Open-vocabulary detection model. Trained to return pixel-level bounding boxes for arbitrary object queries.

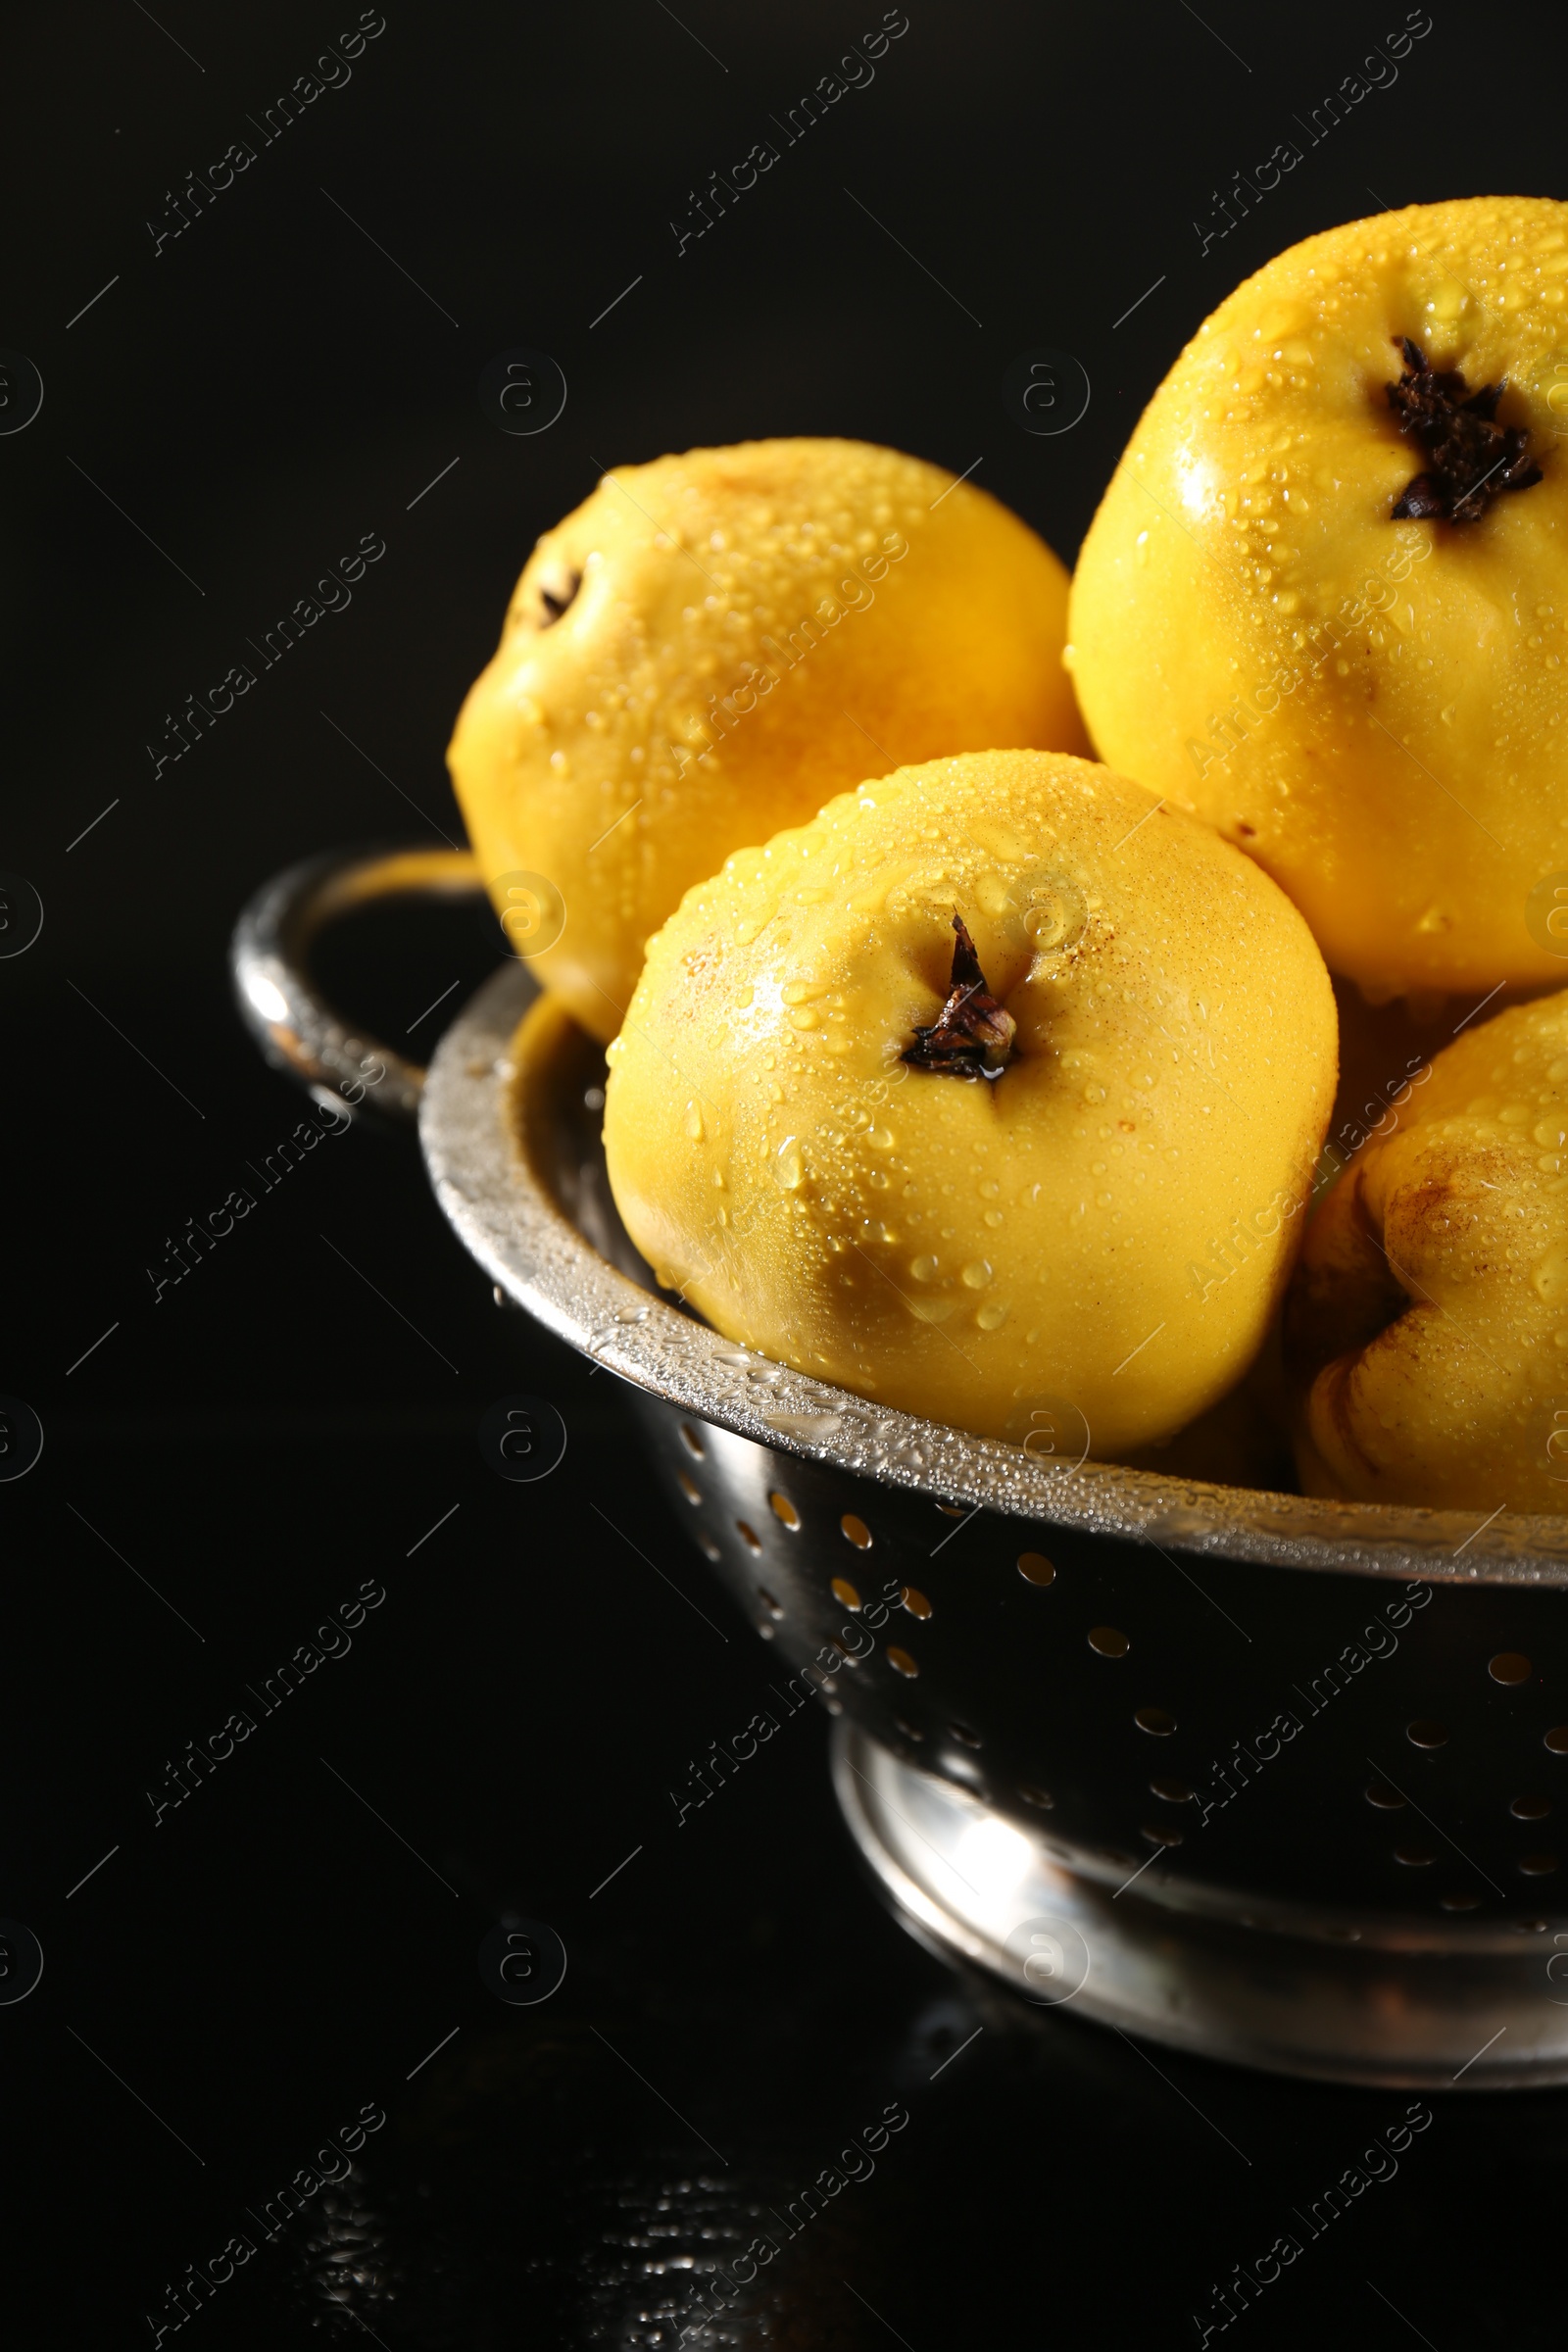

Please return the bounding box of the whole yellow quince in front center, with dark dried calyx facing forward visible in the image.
[604,751,1336,1458]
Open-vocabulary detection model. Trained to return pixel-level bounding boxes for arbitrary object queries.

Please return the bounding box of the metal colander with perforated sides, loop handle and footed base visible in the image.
[235,857,1568,2088]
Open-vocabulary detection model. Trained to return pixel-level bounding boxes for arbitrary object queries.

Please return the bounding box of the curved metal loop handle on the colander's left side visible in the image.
[228,847,484,1127]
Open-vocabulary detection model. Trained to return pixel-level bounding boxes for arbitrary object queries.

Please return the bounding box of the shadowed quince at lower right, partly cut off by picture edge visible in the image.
[1286,995,1568,1510]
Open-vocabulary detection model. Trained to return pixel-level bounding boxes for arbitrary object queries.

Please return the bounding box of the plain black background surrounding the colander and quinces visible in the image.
[0,0,1568,2352]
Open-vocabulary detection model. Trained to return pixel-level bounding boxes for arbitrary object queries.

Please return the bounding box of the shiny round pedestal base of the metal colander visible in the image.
[832,1719,1568,2091]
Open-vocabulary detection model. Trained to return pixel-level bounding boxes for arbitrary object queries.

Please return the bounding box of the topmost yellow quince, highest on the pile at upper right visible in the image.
[1067,198,1568,998]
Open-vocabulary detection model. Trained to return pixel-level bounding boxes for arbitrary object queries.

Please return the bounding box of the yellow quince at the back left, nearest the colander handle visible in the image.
[447,440,1086,1037]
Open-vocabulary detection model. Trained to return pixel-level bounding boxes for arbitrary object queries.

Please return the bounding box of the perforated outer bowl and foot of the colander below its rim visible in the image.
[632,1393,1568,2088]
